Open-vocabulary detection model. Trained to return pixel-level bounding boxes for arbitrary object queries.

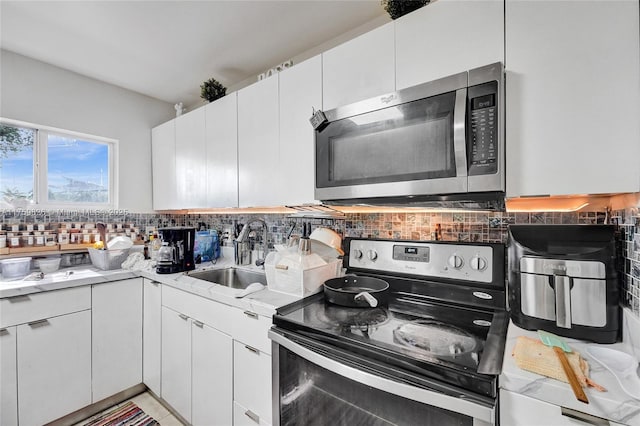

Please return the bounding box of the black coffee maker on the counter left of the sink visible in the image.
[156,226,196,274]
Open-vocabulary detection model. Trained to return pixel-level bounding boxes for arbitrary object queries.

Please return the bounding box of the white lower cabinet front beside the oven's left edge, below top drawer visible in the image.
[233,340,271,422]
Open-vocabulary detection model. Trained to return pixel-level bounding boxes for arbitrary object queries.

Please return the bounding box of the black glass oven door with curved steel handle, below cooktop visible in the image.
[269,327,495,426]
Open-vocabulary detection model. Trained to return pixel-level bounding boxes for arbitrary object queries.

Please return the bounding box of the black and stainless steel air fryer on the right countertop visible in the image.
[508,225,620,343]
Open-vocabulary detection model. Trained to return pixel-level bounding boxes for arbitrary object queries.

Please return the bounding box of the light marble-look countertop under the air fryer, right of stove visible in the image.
[499,313,640,426]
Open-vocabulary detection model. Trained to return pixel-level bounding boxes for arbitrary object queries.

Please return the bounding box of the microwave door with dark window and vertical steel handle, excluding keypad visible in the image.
[315,72,468,201]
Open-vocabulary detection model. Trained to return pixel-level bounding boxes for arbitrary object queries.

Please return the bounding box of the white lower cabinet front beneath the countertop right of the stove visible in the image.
[500,389,622,426]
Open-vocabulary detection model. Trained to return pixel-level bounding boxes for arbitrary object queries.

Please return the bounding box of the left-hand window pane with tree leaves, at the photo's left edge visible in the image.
[0,124,36,207]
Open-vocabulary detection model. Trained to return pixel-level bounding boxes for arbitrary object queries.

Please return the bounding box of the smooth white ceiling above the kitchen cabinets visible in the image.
[0,0,390,106]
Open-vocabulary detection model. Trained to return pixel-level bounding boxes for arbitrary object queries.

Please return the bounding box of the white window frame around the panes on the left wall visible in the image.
[0,118,120,210]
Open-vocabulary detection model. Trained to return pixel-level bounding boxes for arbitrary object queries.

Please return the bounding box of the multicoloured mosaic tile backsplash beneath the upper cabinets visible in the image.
[0,208,640,317]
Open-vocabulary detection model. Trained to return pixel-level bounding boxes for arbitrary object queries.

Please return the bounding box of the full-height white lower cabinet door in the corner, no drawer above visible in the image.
[91,278,142,402]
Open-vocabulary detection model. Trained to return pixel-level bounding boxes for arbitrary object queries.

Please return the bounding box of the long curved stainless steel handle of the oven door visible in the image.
[269,330,495,425]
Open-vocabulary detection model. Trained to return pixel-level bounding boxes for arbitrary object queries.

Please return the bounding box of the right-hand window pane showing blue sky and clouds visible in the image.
[47,135,109,203]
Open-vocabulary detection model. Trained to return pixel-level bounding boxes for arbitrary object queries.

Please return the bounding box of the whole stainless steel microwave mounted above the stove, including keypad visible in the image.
[315,63,505,208]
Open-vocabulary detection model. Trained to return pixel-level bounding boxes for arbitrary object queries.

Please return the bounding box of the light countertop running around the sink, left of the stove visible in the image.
[0,251,299,316]
